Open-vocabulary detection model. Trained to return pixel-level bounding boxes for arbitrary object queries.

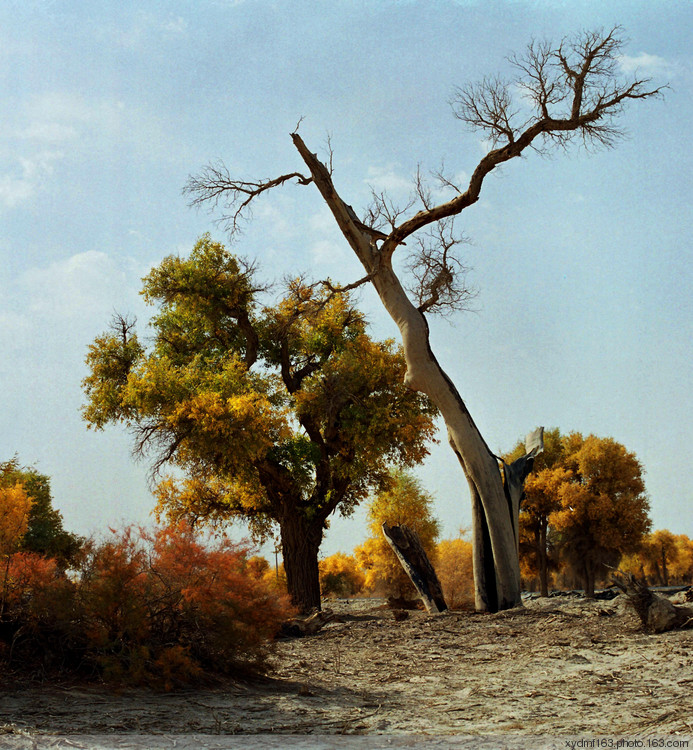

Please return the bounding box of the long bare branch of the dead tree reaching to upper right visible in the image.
[381,27,667,254]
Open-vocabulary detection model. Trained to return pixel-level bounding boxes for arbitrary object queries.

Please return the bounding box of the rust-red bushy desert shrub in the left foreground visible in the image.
[0,525,291,689]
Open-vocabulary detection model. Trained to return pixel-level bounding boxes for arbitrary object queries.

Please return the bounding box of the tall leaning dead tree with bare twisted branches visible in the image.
[186,28,664,611]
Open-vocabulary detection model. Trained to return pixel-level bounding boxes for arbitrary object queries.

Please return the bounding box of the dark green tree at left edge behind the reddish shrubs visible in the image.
[0,457,84,568]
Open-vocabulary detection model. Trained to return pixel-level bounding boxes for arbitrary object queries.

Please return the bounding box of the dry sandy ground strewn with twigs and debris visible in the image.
[0,597,693,747]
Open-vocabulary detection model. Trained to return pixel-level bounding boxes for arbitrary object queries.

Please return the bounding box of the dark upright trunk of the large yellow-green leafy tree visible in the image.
[279,511,322,614]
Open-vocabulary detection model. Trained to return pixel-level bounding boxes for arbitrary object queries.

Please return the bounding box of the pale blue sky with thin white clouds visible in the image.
[0,0,693,554]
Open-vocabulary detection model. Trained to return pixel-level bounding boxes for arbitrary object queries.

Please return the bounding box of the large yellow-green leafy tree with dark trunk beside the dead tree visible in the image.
[84,236,436,611]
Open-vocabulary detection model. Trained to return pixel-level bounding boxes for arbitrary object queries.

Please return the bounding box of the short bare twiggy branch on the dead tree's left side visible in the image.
[183,161,312,234]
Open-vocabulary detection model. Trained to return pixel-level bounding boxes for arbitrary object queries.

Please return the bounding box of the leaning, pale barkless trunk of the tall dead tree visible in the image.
[292,133,521,612]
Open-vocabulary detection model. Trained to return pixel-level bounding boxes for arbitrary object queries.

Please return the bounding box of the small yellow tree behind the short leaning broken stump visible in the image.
[354,471,440,599]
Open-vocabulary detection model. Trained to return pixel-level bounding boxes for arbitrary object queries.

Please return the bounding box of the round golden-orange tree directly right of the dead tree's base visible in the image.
[505,429,650,596]
